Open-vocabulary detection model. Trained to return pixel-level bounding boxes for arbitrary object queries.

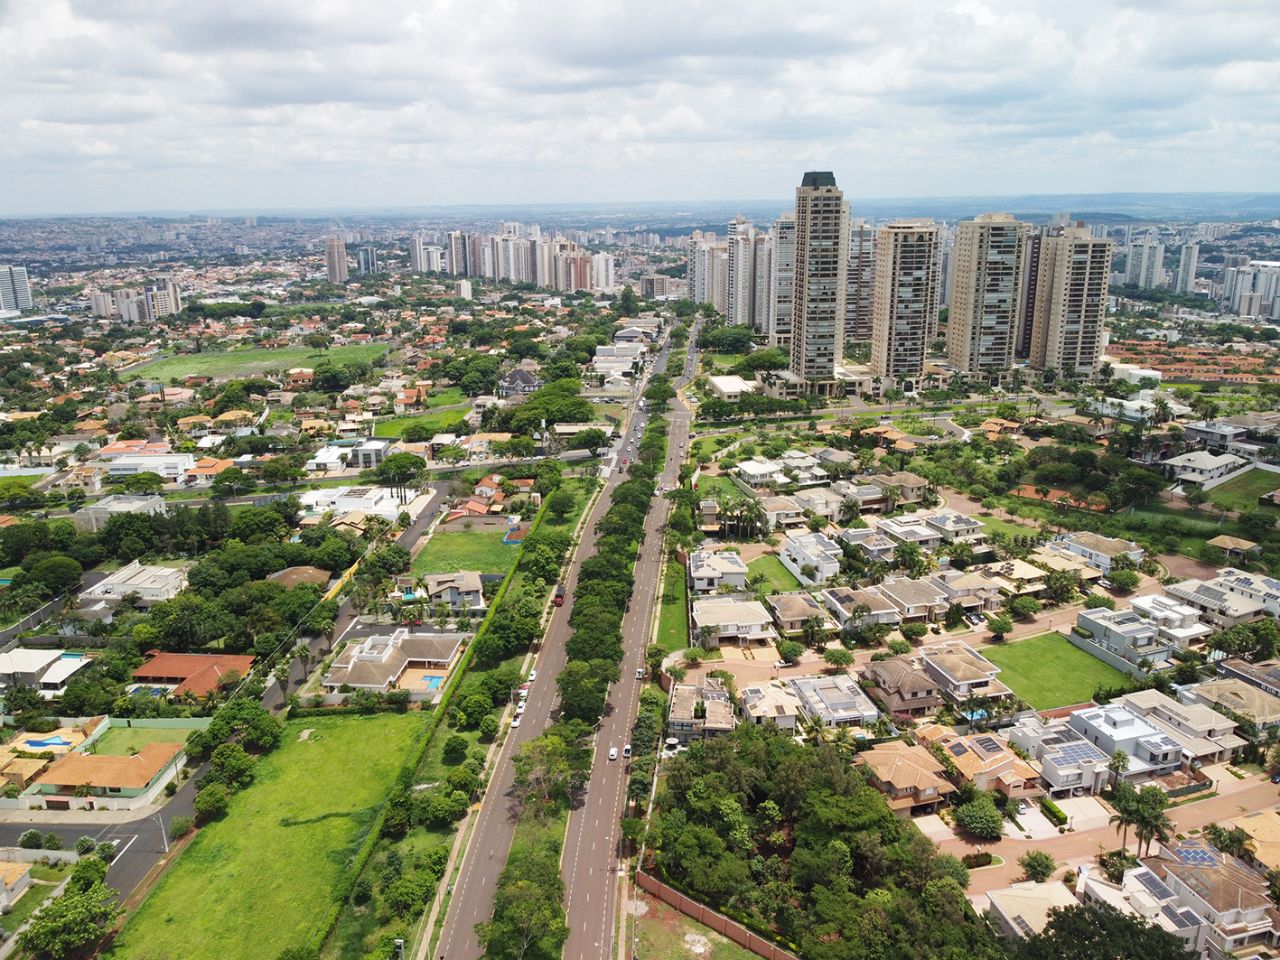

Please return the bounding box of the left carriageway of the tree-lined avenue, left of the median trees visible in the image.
[430,351,687,960]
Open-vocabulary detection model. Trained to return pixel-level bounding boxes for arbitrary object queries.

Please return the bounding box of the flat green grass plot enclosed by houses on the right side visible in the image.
[982,632,1124,710]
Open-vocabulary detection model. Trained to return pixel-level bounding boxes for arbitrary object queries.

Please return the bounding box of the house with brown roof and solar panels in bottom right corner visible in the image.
[1146,840,1280,960]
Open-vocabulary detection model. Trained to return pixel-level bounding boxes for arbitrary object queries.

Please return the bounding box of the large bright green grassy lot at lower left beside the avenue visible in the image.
[104,713,422,960]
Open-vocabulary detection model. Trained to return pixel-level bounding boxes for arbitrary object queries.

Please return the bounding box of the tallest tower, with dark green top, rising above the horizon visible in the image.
[791,170,849,393]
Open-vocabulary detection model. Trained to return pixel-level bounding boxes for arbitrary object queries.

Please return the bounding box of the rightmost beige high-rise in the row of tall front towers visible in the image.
[1030,224,1111,376]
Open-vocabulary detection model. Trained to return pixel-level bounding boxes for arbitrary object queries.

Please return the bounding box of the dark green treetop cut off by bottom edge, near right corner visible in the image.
[1015,904,1199,960]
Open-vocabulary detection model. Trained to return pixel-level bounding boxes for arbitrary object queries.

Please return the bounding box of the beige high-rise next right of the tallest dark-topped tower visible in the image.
[872,220,942,389]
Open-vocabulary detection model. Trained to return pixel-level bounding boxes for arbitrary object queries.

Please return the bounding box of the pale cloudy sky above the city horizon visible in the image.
[0,0,1280,215]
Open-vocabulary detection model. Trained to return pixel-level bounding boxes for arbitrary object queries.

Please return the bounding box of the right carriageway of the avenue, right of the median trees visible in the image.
[561,360,690,960]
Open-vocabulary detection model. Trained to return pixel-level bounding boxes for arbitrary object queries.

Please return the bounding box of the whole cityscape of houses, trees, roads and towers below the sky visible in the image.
[0,179,1280,960]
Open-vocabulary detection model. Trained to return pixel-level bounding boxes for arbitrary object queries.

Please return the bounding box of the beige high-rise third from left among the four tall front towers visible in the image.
[947,214,1025,375]
